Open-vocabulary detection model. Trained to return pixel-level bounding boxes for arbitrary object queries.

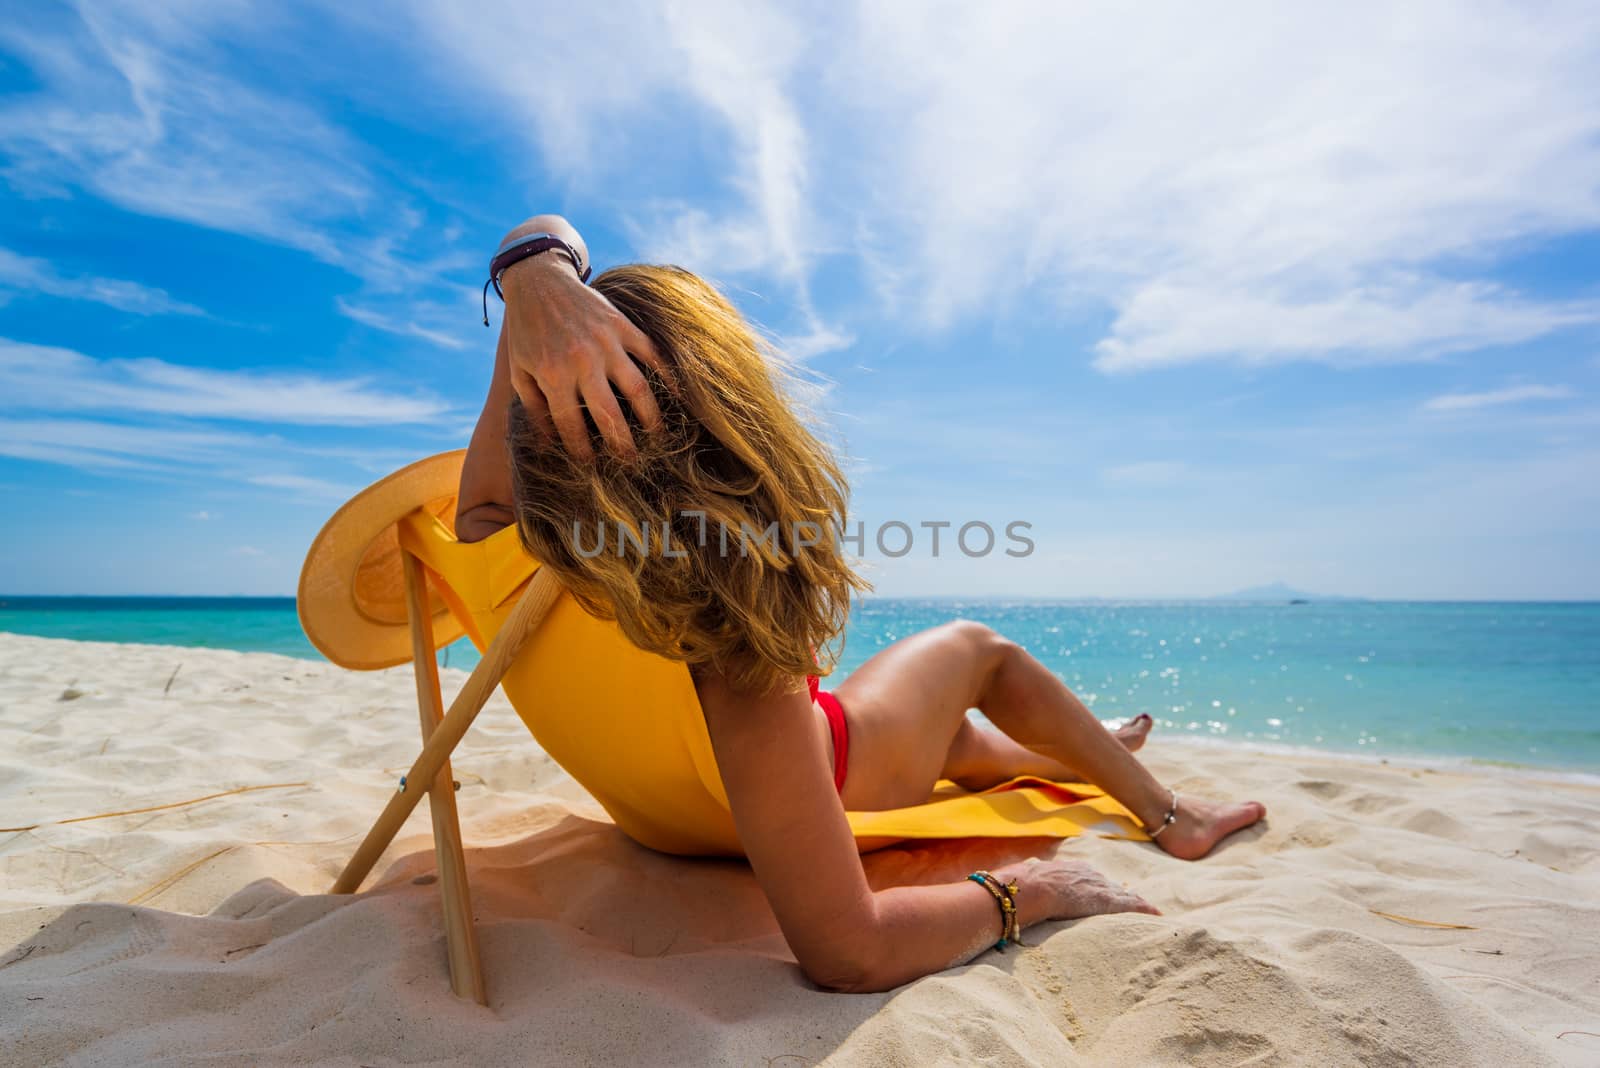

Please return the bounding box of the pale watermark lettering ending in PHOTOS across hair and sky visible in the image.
[573,512,1034,560]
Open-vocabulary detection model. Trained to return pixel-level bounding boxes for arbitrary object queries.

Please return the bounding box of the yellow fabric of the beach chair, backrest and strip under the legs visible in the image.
[400,502,1146,855]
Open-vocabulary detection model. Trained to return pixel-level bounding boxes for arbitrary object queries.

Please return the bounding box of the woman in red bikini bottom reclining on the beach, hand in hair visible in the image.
[456,216,1264,991]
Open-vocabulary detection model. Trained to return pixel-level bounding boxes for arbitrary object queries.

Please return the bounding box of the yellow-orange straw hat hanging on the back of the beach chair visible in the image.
[296,449,467,671]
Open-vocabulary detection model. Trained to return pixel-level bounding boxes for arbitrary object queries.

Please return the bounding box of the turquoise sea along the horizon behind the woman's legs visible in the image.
[0,598,1600,772]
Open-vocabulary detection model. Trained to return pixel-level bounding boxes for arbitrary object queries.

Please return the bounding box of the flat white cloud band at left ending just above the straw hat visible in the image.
[0,339,450,427]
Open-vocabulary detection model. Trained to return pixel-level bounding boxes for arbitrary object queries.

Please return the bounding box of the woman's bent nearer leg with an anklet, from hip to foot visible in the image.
[835,620,1266,859]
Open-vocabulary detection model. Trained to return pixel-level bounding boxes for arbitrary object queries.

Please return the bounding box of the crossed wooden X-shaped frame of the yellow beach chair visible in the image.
[331,550,562,1006]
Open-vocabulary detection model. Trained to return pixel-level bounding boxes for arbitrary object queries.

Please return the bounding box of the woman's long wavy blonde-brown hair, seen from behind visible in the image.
[510,264,869,692]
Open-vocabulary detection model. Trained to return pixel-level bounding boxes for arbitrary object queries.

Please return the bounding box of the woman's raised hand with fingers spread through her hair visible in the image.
[501,253,667,459]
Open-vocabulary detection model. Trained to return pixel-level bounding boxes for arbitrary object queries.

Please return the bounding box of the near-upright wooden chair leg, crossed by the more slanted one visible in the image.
[402,553,488,1006]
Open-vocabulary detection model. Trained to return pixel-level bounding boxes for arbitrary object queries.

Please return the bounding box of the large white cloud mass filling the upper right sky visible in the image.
[842,3,1600,369]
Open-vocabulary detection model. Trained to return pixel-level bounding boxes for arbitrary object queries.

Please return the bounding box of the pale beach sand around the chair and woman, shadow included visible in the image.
[0,635,1600,1068]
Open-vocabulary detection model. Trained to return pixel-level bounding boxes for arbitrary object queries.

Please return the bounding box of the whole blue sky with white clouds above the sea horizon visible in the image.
[0,0,1600,598]
